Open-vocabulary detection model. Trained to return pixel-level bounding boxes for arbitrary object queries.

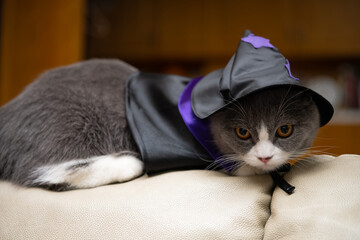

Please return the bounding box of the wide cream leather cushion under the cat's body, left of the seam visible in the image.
[0,171,272,239]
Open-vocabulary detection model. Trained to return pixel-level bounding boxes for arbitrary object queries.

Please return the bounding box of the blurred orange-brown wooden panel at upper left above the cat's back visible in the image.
[0,0,85,106]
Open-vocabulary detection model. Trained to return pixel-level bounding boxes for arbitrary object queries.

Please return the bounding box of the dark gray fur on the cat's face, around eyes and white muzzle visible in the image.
[210,86,320,172]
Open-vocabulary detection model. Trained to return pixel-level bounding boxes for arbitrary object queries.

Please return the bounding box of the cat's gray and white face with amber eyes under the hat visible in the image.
[210,87,320,172]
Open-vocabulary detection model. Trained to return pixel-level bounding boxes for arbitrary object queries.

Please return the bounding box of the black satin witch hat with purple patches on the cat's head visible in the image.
[191,30,334,126]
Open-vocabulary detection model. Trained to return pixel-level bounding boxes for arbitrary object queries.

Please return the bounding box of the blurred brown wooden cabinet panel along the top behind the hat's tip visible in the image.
[88,0,360,61]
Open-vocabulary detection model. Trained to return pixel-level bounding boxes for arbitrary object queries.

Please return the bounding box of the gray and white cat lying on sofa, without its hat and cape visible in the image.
[0,60,319,190]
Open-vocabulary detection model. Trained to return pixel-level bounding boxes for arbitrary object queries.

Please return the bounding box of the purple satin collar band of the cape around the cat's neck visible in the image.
[178,77,235,172]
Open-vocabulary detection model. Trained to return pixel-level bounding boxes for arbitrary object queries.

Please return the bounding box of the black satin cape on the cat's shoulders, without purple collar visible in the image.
[126,72,213,174]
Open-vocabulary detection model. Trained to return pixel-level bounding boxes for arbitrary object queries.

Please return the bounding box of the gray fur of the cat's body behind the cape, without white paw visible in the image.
[0,60,137,187]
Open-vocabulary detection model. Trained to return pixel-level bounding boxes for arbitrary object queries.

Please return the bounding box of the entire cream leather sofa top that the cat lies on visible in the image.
[0,155,360,240]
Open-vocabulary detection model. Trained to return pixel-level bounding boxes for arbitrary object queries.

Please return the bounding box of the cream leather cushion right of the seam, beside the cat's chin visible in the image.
[265,155,360,240]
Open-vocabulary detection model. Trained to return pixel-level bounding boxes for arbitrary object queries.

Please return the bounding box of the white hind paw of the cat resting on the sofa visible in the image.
[33,155,144,188]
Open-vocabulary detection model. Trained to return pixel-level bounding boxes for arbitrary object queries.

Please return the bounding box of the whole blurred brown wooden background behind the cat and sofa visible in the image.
[0,0,360,154]
